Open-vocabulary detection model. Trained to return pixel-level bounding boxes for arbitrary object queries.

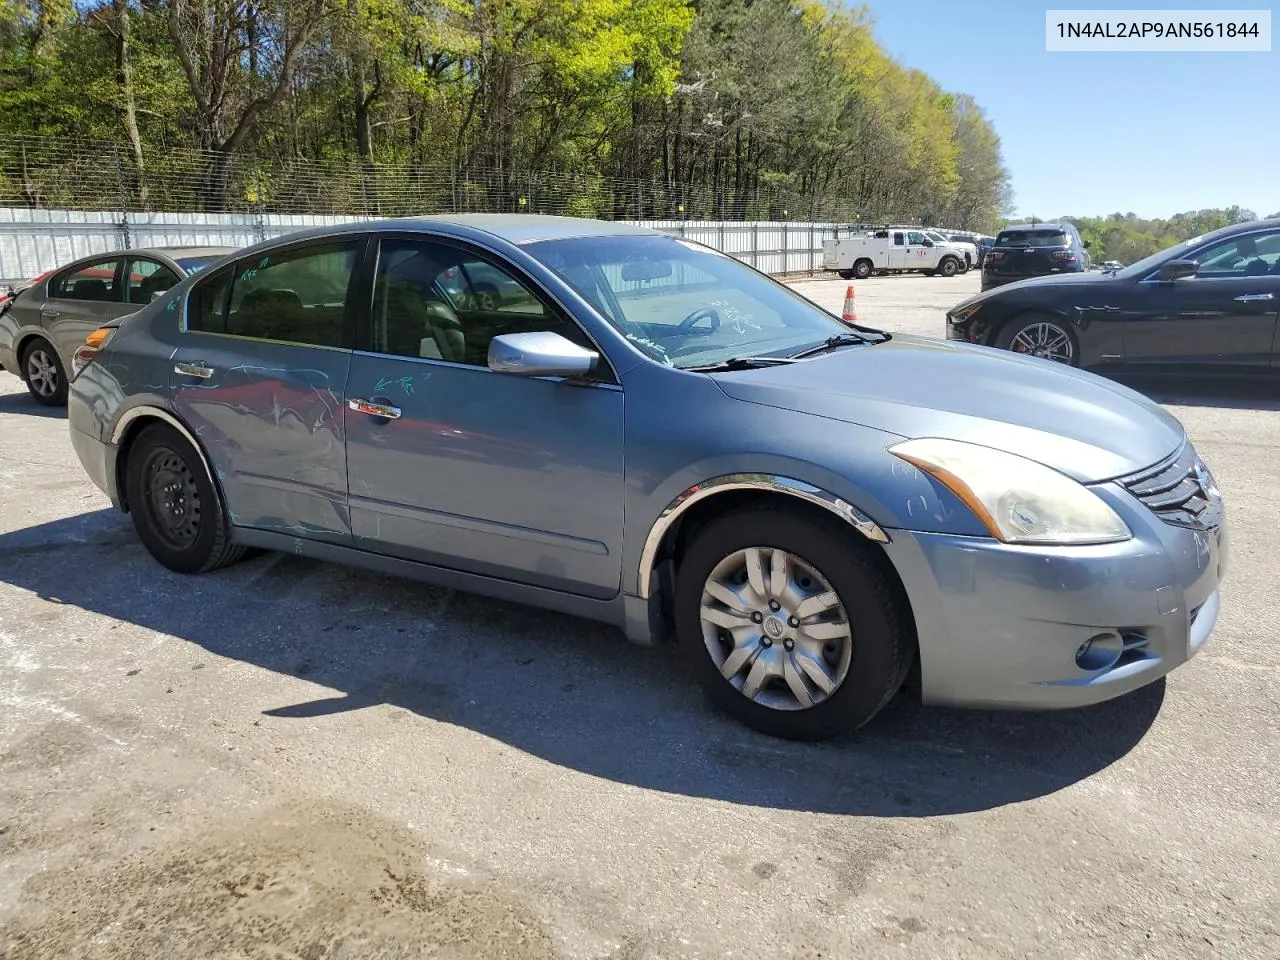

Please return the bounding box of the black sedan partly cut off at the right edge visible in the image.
[947,219,1280,374]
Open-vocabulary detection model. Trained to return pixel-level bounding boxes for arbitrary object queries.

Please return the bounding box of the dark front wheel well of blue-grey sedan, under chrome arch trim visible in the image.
[654,490,919,676]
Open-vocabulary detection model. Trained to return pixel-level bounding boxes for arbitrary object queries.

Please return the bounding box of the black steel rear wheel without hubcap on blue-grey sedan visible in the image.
[124,424,244,573]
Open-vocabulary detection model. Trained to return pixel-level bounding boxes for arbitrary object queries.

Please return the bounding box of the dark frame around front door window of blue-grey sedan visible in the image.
[355,230,622,389]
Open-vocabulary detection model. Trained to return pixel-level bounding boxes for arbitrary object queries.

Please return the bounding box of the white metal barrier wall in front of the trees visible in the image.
[0,207,840,283]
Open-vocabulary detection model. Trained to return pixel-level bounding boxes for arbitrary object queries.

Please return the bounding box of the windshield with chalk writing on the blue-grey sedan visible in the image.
[525,236,865,369]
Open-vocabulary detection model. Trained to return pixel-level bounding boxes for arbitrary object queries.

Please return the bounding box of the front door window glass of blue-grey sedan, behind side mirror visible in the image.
[372,239,570,366]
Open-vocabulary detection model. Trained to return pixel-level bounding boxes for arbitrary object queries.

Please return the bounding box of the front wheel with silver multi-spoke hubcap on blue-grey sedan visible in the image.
[675,506,914,740]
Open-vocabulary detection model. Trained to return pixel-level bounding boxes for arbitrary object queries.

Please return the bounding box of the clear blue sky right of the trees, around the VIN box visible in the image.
[869,0,1280,218]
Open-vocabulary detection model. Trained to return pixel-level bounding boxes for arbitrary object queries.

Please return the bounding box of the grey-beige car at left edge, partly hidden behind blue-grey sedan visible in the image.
[0,247,234,407]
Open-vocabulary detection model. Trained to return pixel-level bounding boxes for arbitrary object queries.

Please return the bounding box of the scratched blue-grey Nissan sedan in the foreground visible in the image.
[69,215,1228,739]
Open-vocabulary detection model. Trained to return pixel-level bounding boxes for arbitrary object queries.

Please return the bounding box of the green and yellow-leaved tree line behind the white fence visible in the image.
[0,0,1010,230]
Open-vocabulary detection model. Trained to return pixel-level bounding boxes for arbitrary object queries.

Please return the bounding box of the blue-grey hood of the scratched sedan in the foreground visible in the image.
[713,335,1187,483]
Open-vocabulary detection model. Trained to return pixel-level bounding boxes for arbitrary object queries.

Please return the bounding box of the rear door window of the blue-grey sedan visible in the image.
[221,241,361,347]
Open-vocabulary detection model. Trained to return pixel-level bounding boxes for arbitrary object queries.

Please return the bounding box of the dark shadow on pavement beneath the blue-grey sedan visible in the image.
[0,509,1165,817]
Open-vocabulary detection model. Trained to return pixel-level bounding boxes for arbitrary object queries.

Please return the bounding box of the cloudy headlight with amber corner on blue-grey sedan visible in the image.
[888,439,1133,544]
